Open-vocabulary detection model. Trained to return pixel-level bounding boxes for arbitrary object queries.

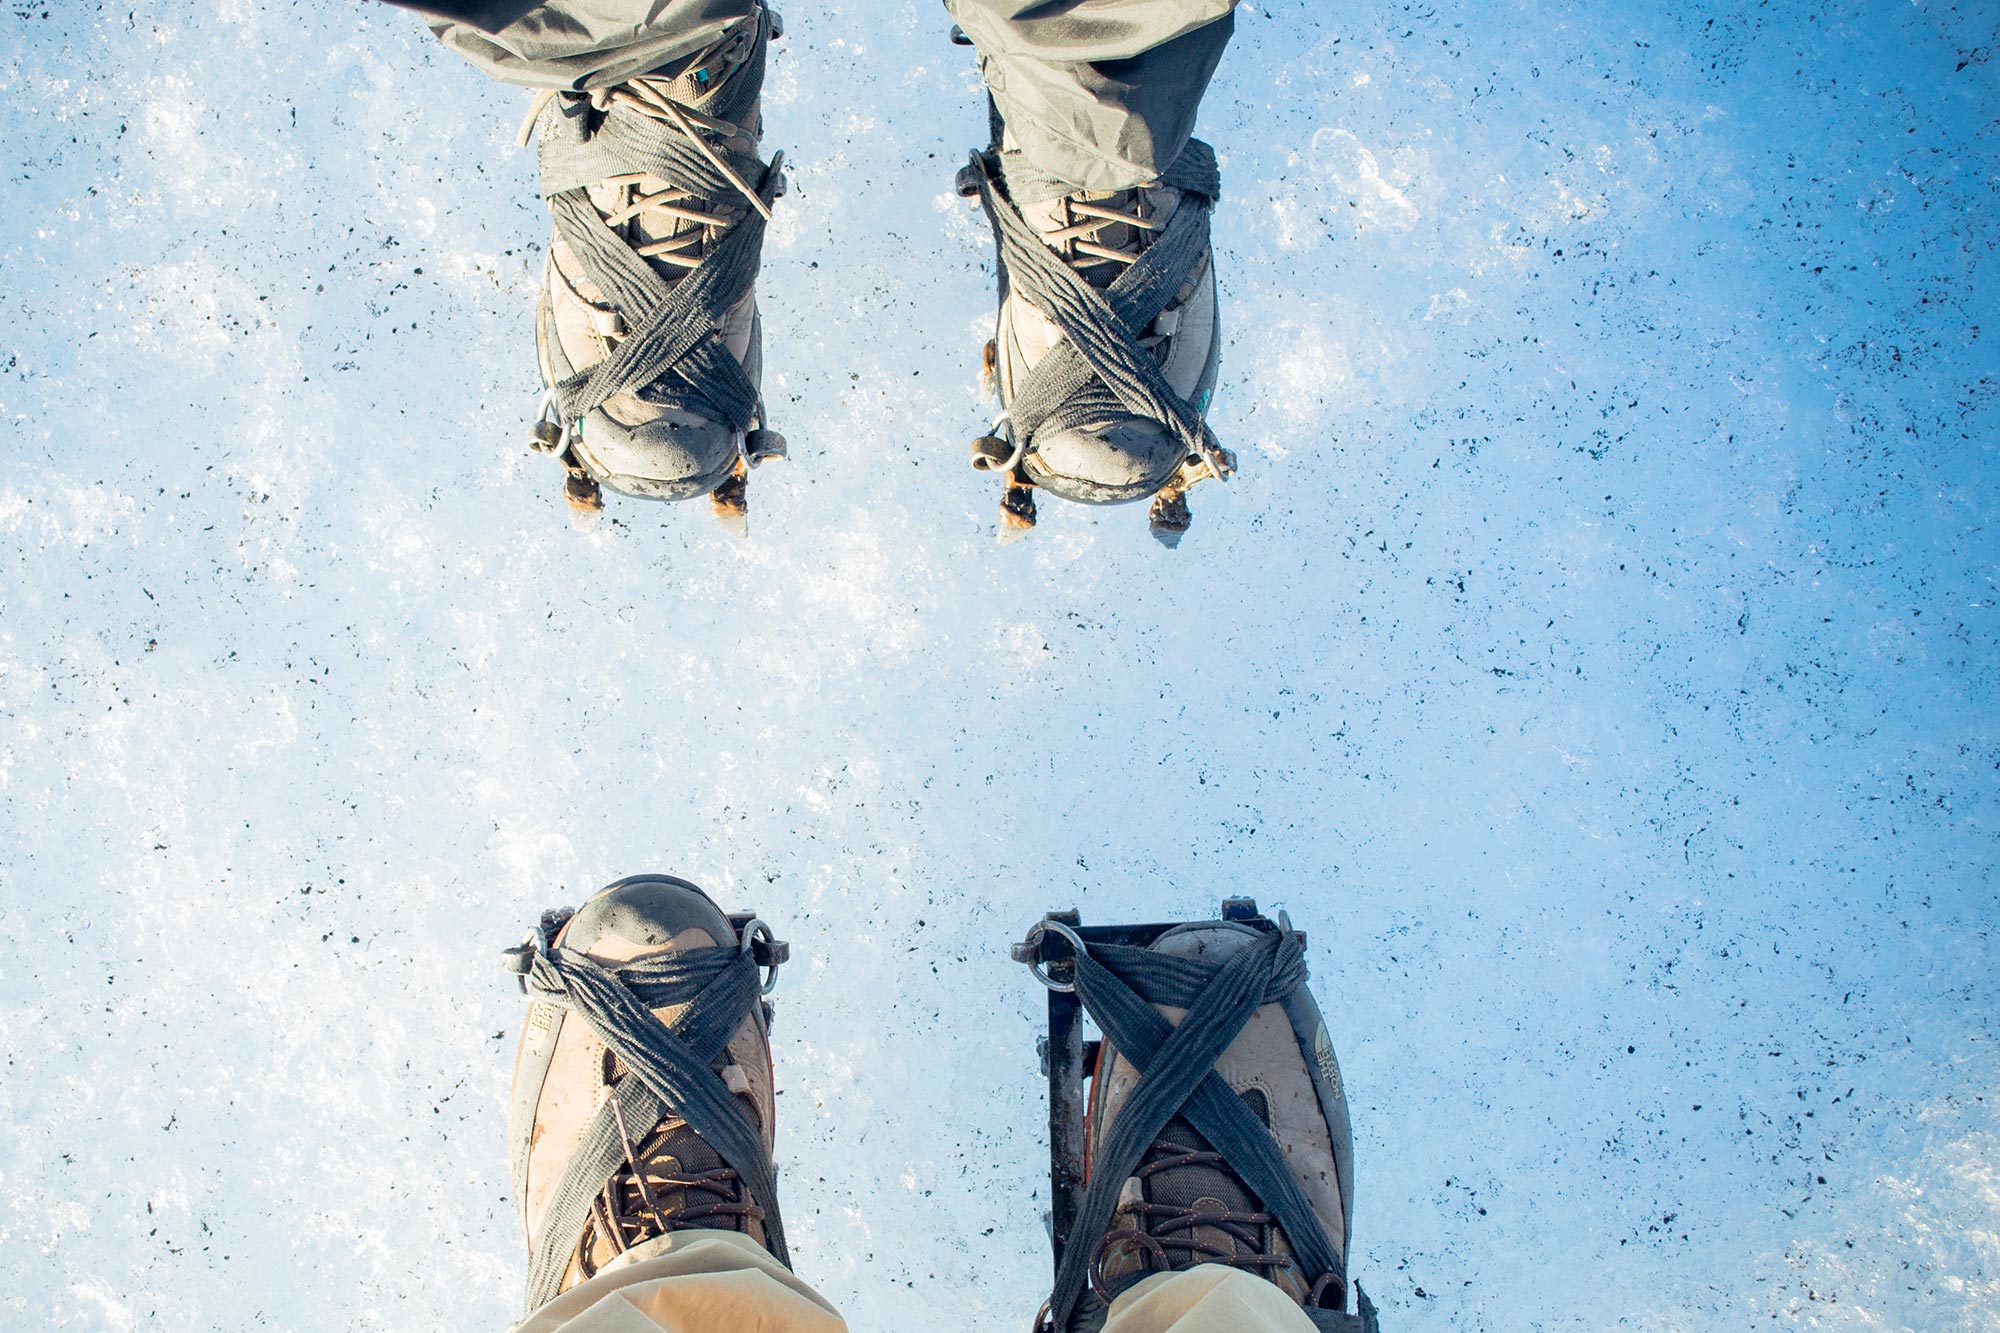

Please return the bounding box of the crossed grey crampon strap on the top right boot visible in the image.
[972,138,1228,476]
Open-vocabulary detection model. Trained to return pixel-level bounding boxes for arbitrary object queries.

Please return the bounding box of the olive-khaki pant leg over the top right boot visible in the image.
[946,0,1236,190]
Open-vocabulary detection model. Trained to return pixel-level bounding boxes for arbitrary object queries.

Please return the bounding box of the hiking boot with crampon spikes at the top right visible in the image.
[960,142,1234,544]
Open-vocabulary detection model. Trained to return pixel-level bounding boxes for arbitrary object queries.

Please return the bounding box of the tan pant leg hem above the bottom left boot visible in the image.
[514,1231,848,1333]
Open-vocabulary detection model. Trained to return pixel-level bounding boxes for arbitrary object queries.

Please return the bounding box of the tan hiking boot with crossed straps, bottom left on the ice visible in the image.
[508,875,790,1311]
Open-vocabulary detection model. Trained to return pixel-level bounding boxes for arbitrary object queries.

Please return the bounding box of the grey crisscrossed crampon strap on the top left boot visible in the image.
[536,10,784,430]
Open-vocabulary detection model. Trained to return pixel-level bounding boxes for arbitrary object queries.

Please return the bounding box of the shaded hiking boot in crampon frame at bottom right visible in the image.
[1014,901,1374,1333]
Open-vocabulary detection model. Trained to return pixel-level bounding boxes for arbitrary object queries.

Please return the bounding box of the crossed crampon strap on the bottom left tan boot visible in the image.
[524,928,792,1311]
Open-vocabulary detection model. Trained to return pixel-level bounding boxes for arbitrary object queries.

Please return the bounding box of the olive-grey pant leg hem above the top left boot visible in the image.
[418,0,758,90]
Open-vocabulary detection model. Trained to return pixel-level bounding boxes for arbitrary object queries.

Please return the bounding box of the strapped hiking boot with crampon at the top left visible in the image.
[522,10,784,520]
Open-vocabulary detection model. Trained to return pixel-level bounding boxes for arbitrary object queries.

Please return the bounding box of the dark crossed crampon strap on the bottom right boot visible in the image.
[1050,929,1374,1333]
